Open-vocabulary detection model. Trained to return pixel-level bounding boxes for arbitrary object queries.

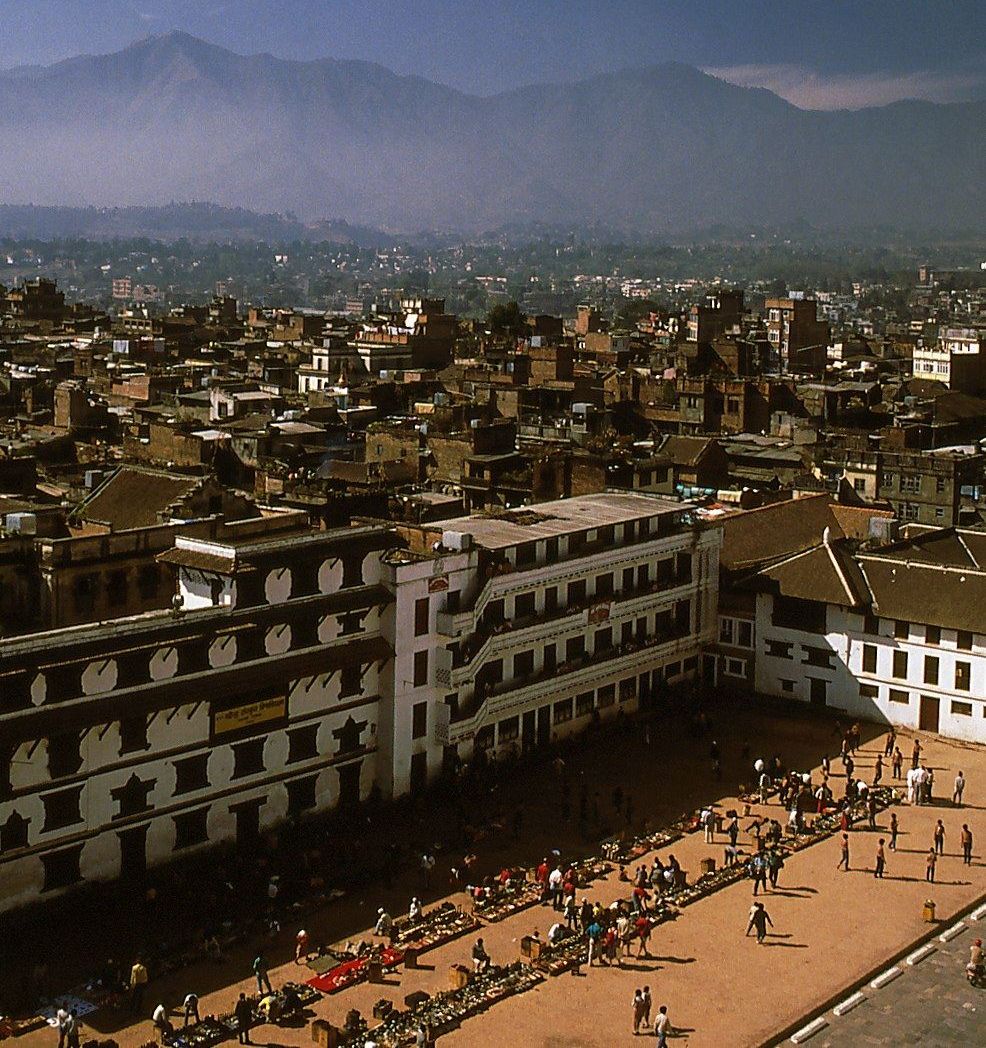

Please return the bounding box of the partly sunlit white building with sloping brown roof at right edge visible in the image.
[737,525,986,743]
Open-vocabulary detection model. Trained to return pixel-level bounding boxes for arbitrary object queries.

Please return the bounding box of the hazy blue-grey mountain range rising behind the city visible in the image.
[0,32,986,234]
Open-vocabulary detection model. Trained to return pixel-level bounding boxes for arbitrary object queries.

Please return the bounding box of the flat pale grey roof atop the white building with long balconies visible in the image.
[439,492,694,549]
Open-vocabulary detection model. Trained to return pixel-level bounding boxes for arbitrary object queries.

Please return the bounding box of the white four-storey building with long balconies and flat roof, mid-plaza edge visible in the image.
[380,493,721,793]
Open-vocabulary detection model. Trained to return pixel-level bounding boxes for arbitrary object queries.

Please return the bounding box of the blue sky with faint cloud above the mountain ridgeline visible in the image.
[0,0,986,108]
